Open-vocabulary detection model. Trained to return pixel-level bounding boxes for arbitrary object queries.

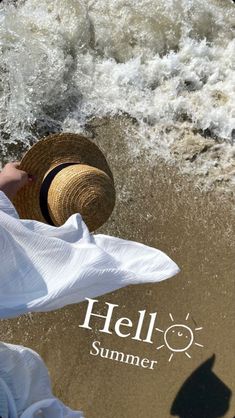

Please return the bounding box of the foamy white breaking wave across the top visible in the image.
[0,0,235,190]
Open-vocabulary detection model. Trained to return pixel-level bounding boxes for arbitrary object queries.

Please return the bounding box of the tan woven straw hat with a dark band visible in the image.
[13,133,115,231]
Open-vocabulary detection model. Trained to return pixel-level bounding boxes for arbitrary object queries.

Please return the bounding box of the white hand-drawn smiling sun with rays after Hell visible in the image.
[156,313,203,361]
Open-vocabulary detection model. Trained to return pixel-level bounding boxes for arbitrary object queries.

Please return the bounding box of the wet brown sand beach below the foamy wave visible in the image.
[0,119,235,418]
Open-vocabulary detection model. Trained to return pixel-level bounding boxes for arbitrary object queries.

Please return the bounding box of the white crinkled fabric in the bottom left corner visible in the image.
[0,342,84,418]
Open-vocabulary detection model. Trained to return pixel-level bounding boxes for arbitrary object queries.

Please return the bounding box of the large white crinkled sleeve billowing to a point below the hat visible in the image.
[0,191,179,318]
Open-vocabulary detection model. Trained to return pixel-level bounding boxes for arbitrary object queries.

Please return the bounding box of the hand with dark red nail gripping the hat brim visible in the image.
[0,161,35,199]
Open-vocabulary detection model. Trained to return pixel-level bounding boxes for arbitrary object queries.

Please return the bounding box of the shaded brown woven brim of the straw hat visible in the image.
[13,133,113,223]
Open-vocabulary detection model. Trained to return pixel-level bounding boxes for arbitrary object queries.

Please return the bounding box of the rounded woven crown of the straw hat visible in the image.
[44,163,115,231]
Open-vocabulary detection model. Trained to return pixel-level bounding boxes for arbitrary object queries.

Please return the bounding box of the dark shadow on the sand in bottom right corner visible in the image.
[171,355,232,418]
